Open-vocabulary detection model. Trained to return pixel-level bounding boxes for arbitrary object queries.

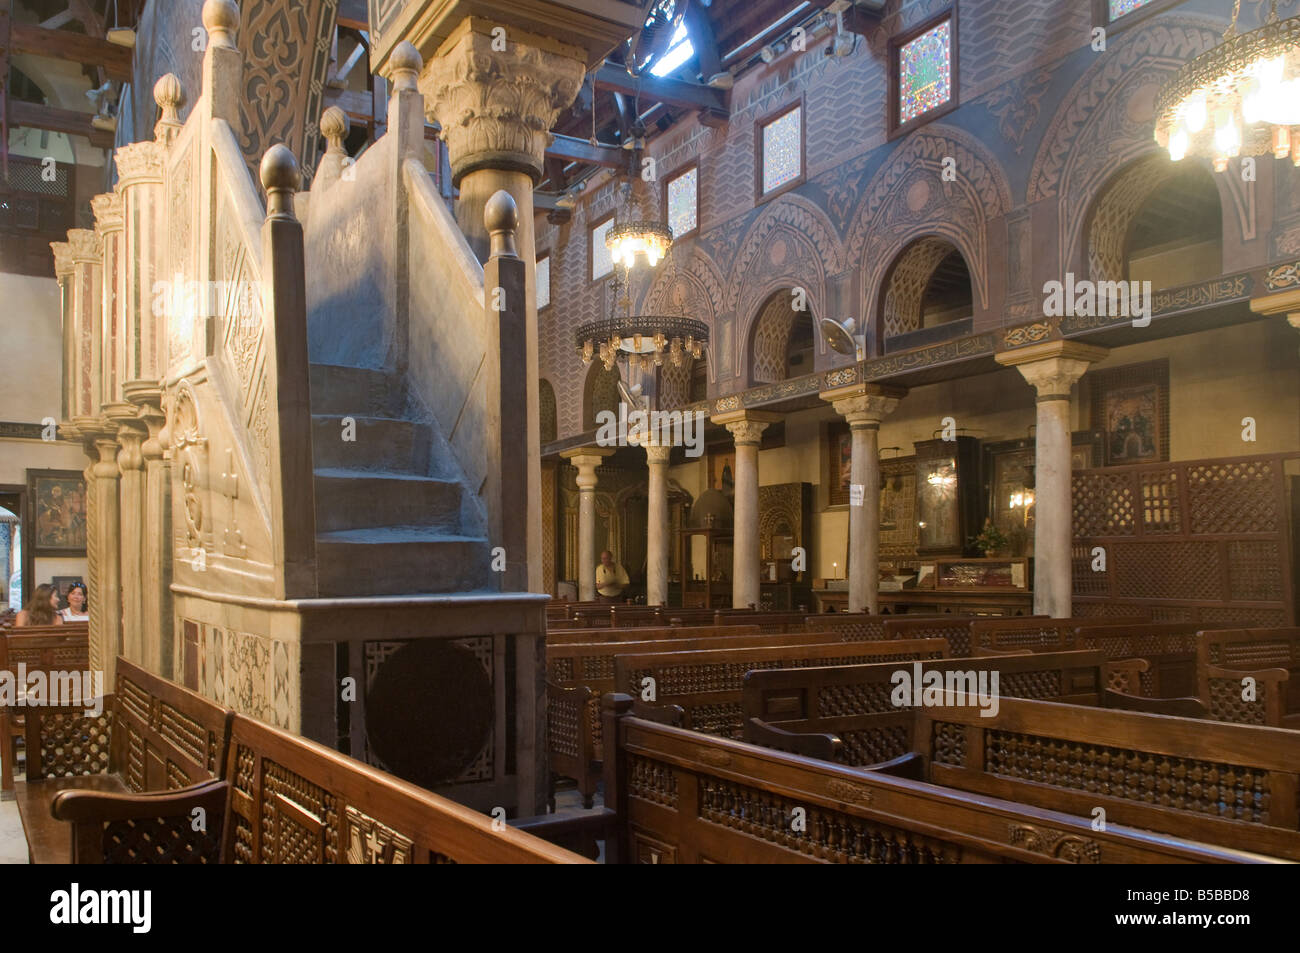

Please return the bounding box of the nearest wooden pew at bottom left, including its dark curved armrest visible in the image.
[53,715,586,863]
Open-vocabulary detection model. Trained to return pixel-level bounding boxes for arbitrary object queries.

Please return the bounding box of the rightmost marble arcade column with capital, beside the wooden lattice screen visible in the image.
[997,341,1109,619]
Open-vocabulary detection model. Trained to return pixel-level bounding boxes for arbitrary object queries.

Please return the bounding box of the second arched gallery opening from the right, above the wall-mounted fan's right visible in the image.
[879,238,975,352]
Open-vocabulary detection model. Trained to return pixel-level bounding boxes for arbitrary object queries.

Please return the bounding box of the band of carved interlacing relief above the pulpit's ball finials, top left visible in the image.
[238,0,338,182]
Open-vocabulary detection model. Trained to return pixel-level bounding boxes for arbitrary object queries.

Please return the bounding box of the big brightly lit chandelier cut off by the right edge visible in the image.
[1156,0,1300,172]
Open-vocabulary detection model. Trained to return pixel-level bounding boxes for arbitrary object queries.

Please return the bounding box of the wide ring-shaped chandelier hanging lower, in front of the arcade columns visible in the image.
[576,252,709,371]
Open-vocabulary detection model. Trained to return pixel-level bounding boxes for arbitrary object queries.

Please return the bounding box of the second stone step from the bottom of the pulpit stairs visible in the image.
[316,469,460,533]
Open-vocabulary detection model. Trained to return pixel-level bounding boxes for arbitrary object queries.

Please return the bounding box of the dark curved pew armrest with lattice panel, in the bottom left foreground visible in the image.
[49,780,230,863]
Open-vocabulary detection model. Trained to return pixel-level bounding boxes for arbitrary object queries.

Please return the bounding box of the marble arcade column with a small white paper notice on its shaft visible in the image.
[822,385,906,615]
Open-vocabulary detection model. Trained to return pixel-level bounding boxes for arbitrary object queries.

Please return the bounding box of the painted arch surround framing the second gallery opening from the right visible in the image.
[845,124,1011,326]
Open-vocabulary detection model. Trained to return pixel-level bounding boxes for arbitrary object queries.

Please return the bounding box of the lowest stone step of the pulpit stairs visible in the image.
[316,527,491,597]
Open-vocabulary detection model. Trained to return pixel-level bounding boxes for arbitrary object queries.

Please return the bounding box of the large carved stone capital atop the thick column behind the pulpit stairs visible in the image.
[419,18,586,185]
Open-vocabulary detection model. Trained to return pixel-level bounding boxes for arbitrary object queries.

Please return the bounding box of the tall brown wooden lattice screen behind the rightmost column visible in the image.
[1073,454,1296,625]
